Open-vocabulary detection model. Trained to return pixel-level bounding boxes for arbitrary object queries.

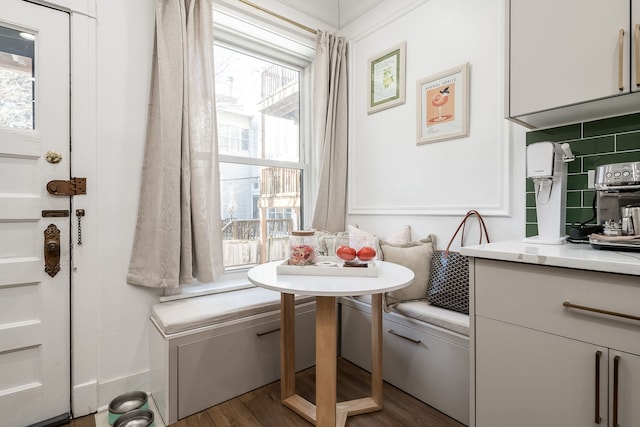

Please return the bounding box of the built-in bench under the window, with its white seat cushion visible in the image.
[150,288,315,425]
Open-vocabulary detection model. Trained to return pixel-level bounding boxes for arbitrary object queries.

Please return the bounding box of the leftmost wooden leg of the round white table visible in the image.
[280,293,296,401]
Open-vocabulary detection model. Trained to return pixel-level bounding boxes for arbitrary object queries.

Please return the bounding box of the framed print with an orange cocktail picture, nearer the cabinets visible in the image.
[416,63,469,145]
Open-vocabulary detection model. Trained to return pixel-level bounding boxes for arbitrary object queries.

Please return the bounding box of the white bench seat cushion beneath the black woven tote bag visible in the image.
[348,295,469,336]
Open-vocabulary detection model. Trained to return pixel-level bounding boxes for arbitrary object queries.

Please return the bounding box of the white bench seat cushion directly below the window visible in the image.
[151,287,314,335]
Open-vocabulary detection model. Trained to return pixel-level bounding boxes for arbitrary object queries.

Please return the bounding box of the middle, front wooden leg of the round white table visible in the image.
[316,296,337,427]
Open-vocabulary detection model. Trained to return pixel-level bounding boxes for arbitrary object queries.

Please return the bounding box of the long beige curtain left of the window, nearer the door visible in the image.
[127,0,223,288]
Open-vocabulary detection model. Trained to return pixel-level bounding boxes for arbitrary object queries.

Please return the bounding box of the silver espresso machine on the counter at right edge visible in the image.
[589,162,640,250]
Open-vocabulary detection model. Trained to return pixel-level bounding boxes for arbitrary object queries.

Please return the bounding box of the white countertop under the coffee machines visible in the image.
[460,240,640,276]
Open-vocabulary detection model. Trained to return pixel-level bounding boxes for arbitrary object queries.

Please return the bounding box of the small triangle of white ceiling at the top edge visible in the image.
[279,0,384,29]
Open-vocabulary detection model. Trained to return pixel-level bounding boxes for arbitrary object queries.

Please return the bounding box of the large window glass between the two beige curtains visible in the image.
[214,44,305,272]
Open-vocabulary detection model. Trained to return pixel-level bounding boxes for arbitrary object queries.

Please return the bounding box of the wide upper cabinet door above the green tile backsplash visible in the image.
[509,0,637,117]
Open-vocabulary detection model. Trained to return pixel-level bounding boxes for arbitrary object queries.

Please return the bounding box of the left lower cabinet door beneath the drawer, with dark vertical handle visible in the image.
[475,316,607,427]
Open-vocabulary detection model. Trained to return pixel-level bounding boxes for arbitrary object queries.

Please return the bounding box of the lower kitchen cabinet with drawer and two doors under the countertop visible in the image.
[470,258,640,427]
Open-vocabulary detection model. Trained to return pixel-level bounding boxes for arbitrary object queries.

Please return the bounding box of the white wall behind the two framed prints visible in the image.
[341,0,525,248]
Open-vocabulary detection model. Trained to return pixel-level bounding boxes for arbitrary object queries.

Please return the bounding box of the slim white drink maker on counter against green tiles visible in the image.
[525,141,575,245]
